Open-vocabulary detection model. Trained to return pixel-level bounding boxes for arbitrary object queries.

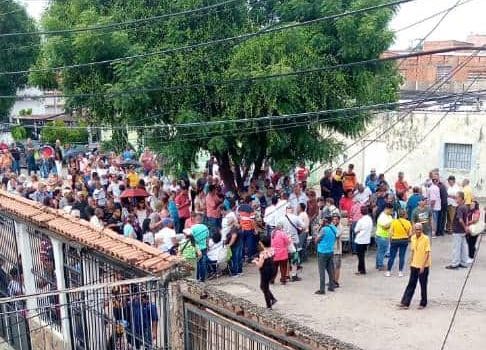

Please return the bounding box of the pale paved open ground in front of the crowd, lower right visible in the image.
[214,236,486,350]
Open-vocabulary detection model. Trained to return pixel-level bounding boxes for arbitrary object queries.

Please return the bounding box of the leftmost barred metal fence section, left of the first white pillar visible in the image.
[0,215,31,350]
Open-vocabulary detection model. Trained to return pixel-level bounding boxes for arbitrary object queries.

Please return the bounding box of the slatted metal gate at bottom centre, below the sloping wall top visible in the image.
[184,302,291,350]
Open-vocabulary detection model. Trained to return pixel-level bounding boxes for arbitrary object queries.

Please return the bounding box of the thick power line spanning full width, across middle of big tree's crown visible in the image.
[0,46,482,100]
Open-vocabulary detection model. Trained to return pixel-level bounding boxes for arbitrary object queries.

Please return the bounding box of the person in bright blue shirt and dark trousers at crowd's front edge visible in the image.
[315,217,339,294]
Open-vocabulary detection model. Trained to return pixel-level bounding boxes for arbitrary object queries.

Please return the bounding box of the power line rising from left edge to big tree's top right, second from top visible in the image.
[0,0,415,75]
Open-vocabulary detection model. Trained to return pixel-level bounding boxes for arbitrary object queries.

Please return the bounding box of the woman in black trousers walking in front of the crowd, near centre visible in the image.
[253,236,277,309]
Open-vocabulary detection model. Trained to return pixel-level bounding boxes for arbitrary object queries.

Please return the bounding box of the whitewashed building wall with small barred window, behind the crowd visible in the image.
[333,111,486,197]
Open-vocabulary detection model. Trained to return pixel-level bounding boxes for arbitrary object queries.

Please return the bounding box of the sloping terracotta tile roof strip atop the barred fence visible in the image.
[0,190,179,274]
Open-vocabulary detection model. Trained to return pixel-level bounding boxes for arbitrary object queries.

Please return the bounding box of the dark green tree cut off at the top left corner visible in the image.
[0,0,40,121]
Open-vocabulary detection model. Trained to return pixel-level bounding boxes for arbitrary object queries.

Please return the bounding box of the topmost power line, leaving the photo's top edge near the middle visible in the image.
[0,0,242,38]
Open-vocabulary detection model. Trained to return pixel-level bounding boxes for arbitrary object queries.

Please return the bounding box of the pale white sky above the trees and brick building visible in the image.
[17,0,486,49]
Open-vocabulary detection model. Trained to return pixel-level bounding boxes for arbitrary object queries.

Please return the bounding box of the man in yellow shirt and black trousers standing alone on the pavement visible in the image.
[399,223,431,309]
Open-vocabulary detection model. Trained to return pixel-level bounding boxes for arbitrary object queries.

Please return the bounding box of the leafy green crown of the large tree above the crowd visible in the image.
[33,0,400,191]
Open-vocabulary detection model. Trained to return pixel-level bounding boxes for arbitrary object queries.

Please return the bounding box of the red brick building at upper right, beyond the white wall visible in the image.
[385,35,486,92]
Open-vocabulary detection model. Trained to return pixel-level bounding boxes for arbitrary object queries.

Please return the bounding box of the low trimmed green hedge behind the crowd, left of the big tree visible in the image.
[41,120,88,144]
